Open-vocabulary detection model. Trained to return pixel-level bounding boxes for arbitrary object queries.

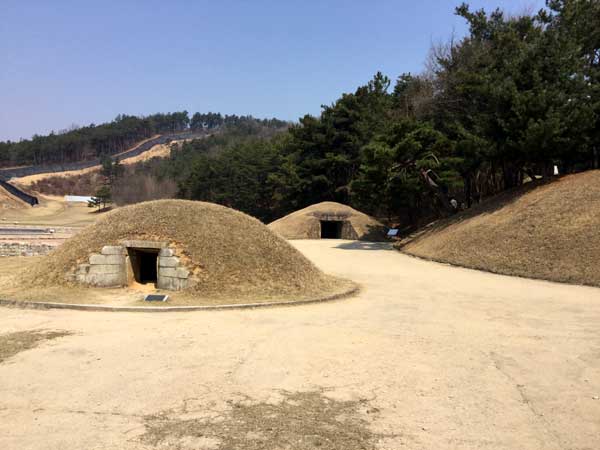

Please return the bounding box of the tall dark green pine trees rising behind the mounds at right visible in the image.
[168,0,600,229]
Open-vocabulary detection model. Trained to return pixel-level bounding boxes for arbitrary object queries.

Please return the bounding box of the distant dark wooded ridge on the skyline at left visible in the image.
[0,111,287,167]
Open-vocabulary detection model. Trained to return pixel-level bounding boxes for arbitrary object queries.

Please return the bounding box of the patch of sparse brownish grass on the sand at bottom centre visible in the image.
[141,391,383,450]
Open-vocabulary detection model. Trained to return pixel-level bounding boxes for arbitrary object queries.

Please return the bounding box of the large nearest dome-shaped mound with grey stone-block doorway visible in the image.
[24,200,344,297]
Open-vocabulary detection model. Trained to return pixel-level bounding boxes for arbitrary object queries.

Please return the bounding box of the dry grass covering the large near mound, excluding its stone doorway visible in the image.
[13,200,348,303]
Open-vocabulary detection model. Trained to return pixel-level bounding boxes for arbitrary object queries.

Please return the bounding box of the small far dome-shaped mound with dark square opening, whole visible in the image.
[269,202,386,241]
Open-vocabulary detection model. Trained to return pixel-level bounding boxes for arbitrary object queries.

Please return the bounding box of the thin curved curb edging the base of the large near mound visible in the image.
[0,285,360,313]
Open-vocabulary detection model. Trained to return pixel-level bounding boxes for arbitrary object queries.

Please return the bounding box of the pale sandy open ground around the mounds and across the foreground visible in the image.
[0,241,600,450]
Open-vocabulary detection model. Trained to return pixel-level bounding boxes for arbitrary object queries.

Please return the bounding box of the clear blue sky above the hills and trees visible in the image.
[0,0,544,140]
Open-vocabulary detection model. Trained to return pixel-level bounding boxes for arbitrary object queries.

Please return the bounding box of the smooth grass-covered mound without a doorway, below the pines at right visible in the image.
[399,170,600,286]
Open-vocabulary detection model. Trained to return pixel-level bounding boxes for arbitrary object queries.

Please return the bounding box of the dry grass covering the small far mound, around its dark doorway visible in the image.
[269,202,385,241]
